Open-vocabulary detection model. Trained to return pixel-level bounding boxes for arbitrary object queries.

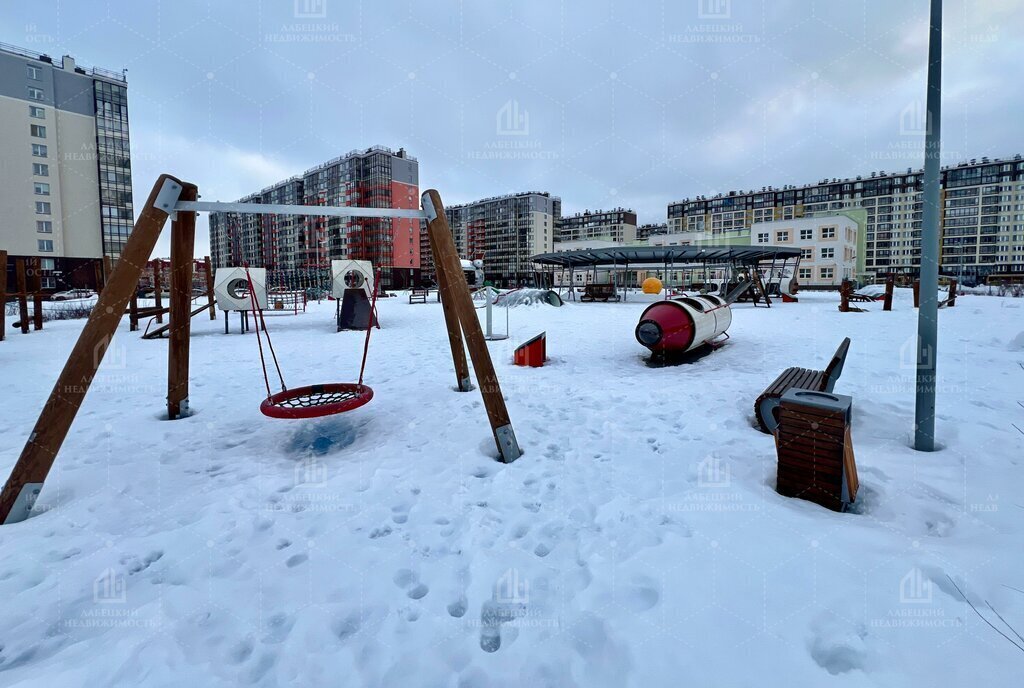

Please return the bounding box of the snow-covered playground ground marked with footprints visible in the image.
[0,290,1024,687]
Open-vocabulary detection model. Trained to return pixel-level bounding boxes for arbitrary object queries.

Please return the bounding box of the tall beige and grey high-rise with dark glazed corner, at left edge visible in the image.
[0,45,134,290]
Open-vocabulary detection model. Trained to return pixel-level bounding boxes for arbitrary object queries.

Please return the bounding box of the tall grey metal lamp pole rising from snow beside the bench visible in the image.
[913,0,942,452]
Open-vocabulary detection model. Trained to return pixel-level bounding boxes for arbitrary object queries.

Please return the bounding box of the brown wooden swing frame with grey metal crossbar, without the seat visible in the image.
[0,174,522,524]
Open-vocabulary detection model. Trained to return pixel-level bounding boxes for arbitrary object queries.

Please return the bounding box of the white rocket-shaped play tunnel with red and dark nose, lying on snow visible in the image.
[636,294,732,353]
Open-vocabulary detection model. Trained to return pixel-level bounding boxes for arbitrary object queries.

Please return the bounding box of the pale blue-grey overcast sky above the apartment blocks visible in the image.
[0,0,1024,255]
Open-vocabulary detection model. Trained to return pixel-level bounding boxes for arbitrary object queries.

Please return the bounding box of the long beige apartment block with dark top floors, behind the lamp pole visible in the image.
[669,155,1024,282]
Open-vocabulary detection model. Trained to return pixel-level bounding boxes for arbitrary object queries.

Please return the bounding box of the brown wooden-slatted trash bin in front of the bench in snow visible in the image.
[775,388,858,511]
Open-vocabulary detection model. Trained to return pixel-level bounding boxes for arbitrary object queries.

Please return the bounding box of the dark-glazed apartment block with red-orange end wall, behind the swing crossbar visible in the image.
[210,146,420,288]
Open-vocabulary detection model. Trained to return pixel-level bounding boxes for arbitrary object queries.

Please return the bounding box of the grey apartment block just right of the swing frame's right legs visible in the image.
[420,191,562,287]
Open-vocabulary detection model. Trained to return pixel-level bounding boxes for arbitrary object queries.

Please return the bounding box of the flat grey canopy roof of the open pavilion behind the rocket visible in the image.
[530,245,800,267]
